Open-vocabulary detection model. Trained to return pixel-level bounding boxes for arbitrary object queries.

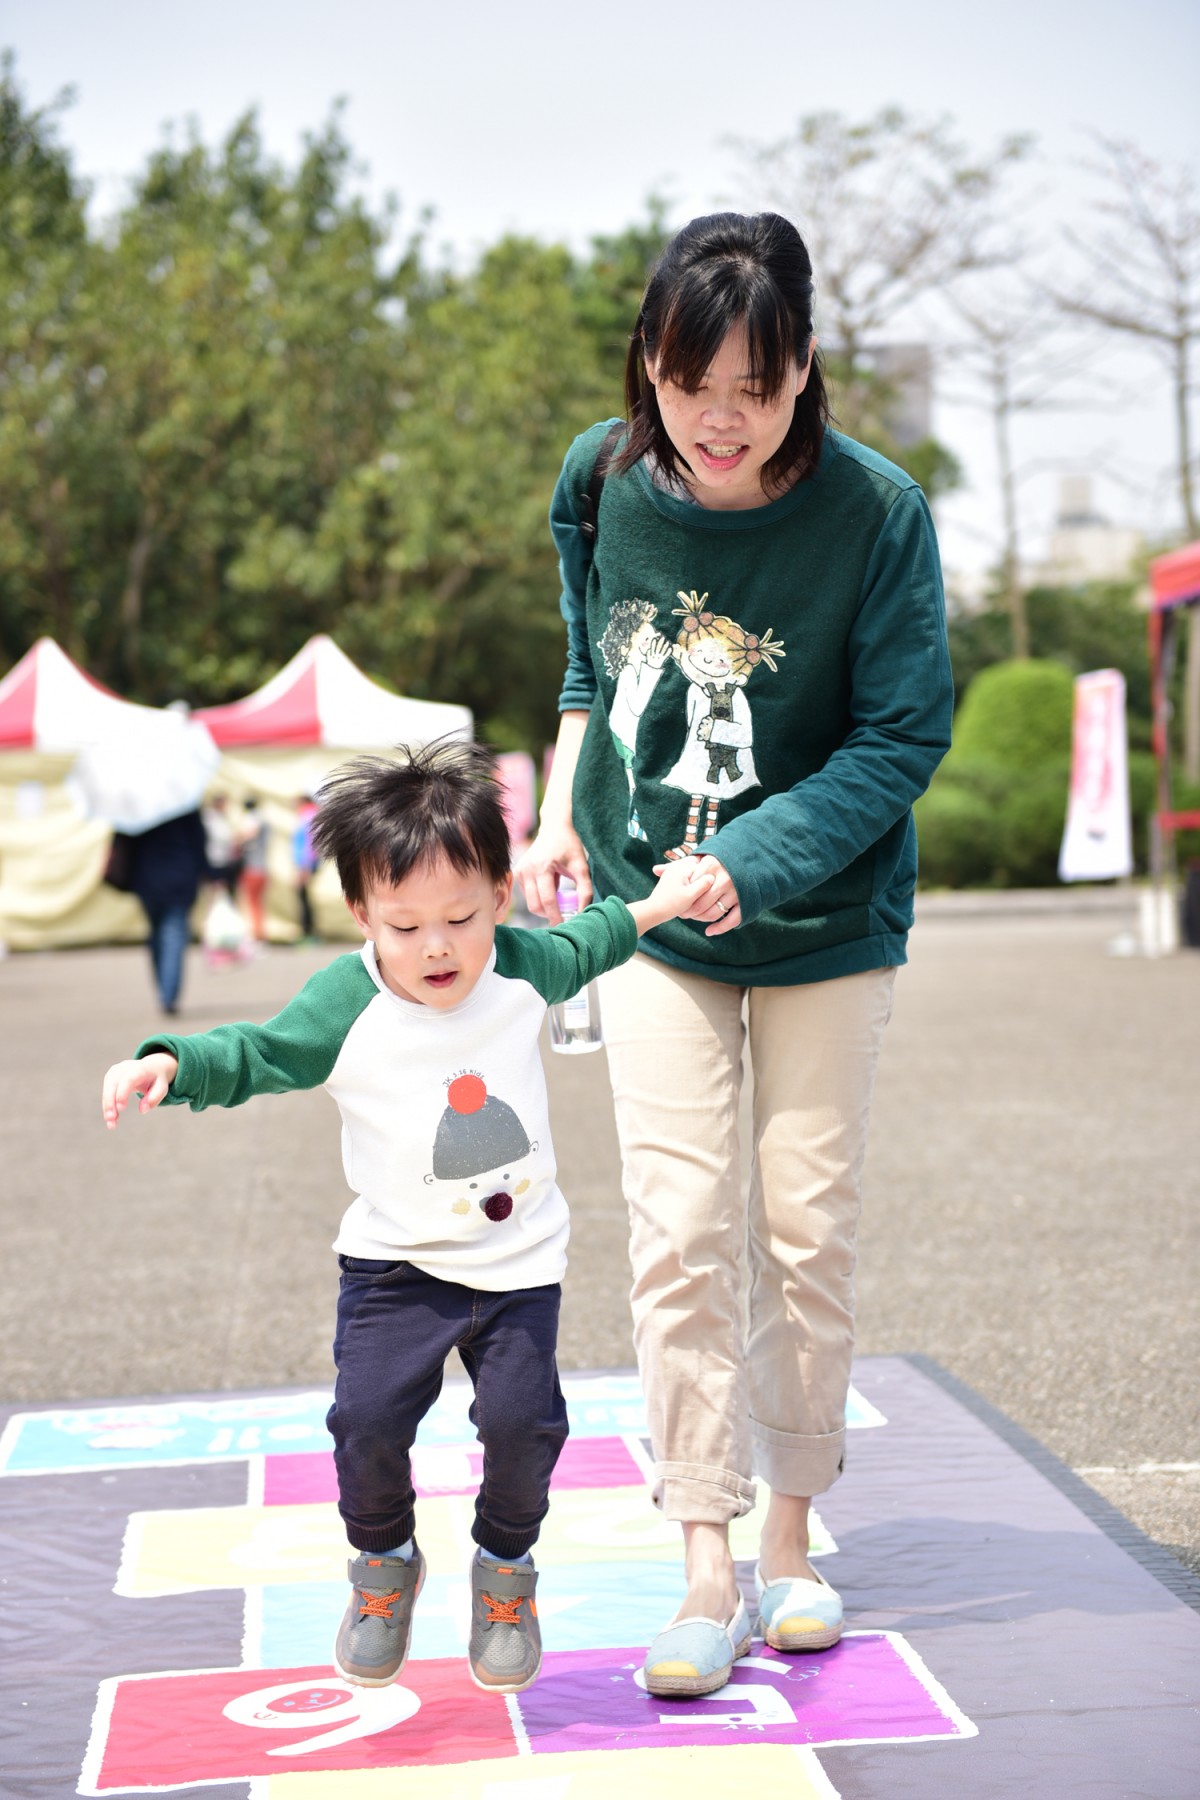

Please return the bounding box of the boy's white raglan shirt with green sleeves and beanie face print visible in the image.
[137,898,637,1292]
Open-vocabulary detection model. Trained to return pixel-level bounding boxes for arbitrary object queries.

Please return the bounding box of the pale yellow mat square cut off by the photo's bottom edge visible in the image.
[255,1744,838,1800]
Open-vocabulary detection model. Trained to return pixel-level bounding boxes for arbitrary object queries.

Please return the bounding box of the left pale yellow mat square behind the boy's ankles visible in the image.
[115,1496,473,1598]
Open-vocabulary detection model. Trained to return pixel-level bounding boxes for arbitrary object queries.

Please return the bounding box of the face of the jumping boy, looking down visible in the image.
[351,857,513,1012]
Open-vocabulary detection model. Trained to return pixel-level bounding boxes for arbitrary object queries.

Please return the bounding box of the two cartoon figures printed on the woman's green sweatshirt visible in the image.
[611,589,784,860]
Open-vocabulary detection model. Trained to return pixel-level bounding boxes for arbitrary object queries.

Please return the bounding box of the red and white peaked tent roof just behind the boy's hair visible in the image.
[194,635,471,751]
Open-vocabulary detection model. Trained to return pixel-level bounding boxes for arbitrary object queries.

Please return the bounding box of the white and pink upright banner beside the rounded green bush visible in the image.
[1058,670,1133,882]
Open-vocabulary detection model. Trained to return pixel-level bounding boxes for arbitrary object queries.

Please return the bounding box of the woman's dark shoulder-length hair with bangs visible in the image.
[612,212,829,495]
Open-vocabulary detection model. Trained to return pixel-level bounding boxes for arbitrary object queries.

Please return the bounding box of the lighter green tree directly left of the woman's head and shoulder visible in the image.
[278,238,619,743]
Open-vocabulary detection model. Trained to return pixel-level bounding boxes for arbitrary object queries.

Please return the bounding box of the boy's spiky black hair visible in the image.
[313,738,511,905]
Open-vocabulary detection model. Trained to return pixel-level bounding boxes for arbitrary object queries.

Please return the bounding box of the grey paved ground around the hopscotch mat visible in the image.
[0,896,1200,1571]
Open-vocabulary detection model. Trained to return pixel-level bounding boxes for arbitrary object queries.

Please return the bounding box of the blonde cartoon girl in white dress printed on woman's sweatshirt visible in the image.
[662,589,784,860]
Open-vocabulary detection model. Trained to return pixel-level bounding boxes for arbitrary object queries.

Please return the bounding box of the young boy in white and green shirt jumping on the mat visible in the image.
[103,742,707,1694]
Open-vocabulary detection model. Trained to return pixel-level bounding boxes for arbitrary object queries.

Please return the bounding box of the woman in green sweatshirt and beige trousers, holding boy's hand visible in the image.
[518,212,952,1694]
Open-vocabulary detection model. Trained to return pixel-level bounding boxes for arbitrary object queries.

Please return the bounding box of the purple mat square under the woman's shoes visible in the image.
[515,1631,973,1753]
